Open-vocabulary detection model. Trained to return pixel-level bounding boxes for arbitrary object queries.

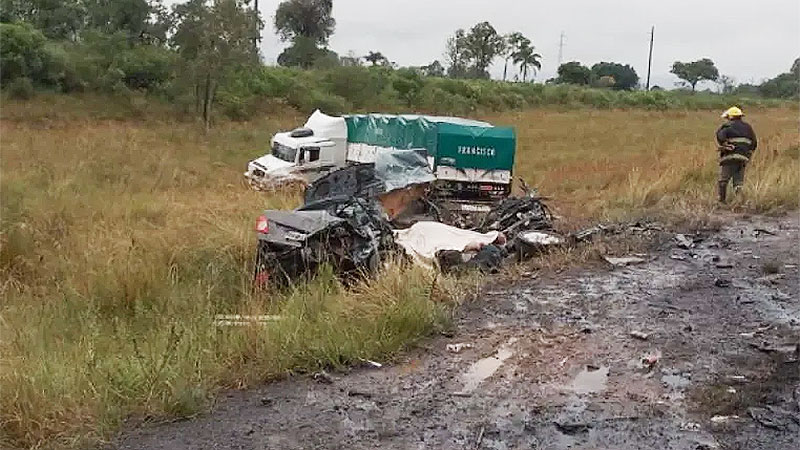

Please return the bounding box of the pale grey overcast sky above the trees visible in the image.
[192,0,800,88]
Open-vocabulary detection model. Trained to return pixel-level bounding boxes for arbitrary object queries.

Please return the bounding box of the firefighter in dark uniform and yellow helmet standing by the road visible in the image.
[717,106,758,203]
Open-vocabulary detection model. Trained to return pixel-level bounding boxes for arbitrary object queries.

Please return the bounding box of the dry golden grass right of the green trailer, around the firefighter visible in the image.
[490,109,800,222]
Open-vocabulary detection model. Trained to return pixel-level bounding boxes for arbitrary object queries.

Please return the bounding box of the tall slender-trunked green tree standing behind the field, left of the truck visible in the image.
[171,0,263,131]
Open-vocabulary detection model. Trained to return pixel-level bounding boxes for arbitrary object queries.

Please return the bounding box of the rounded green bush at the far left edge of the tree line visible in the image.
[0,23,46,84]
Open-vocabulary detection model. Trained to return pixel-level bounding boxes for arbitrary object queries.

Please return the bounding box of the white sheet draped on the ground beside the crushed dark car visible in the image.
[394,221,500,267]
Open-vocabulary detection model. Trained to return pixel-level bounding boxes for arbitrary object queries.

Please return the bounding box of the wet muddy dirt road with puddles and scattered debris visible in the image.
[112,214,800,449]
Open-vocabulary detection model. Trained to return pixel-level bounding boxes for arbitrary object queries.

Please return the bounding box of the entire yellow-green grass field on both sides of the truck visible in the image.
[0,97,800,447]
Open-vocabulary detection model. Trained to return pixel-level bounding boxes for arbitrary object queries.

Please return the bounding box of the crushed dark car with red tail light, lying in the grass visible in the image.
[254,197,394,288]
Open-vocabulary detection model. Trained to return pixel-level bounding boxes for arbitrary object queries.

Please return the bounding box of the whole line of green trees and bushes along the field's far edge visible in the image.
[0,0,800,126]
